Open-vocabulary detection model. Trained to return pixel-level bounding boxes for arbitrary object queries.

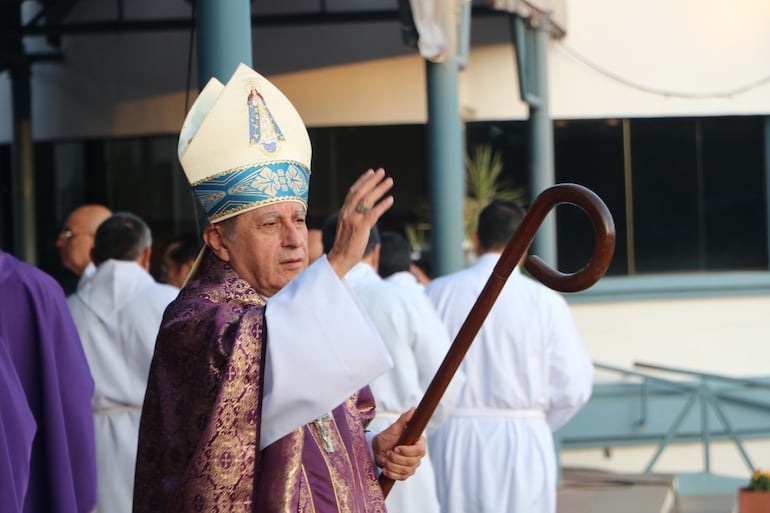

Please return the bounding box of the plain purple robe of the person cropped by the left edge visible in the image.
[0,251,96,513]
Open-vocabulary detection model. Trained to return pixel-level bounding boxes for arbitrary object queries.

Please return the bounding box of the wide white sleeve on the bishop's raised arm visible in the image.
[260,256,393,449]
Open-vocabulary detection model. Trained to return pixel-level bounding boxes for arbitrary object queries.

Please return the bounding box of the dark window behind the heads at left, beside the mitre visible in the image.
[29,136,200,290]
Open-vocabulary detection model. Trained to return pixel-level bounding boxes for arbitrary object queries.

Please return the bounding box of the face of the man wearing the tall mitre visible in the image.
[207,201,308,297]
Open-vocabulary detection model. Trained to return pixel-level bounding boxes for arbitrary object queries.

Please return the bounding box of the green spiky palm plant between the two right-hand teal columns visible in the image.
[463,144,527,243]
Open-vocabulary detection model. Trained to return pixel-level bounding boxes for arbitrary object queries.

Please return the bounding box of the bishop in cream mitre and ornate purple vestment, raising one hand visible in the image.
[134,65,425,513]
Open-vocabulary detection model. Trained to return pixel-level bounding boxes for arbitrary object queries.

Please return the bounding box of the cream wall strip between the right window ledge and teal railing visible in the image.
[570,296,770,377]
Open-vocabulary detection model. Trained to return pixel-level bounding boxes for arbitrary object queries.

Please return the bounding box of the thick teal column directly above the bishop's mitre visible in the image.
[195,0,252,89]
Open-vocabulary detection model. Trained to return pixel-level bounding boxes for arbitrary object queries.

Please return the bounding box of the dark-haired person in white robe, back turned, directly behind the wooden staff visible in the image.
[426,201,593,513]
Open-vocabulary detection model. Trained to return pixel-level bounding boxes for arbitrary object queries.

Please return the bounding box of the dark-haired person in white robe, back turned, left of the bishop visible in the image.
[67,212,178,513]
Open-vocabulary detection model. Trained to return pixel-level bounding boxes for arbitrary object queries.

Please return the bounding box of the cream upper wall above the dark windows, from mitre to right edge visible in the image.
[255,0,770,124]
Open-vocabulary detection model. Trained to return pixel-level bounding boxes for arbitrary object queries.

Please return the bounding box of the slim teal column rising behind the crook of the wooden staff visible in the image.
[510,14,557,266]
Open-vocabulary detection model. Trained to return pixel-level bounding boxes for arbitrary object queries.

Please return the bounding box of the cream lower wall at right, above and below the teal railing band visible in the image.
[561,296,770,482]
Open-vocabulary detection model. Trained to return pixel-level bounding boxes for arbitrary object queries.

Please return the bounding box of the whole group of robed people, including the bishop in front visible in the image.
[0,65,592,513]
